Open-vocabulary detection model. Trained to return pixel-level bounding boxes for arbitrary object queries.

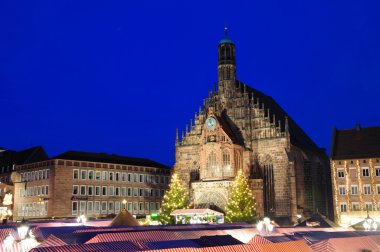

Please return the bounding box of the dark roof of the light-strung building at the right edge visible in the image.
[330,125,380,159]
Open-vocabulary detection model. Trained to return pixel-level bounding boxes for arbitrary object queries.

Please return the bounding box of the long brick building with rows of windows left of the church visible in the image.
[12,151,170,220]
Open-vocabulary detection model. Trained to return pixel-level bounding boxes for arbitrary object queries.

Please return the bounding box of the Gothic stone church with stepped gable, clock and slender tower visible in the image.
[174,29,332,222]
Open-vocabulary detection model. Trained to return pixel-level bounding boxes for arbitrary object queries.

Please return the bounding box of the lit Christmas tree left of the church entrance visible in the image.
[159,173,188,224]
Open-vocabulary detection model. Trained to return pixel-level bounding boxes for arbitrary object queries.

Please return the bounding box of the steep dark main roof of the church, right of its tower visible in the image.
[236,81,323,151]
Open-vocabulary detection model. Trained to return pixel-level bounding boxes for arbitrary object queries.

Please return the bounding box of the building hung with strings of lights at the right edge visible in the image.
[330,125,380,225]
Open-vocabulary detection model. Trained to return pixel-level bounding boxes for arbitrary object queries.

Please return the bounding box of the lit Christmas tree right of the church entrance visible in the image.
[226,171,256,222]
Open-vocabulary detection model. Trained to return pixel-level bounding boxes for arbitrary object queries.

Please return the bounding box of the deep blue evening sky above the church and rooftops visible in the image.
[0,0,380,165]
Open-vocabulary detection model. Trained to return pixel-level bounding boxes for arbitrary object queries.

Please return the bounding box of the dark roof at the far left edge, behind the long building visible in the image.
[0,146,48,166]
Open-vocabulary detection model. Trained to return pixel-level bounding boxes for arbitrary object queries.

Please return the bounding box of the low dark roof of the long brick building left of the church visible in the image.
[52,151,170,169]
